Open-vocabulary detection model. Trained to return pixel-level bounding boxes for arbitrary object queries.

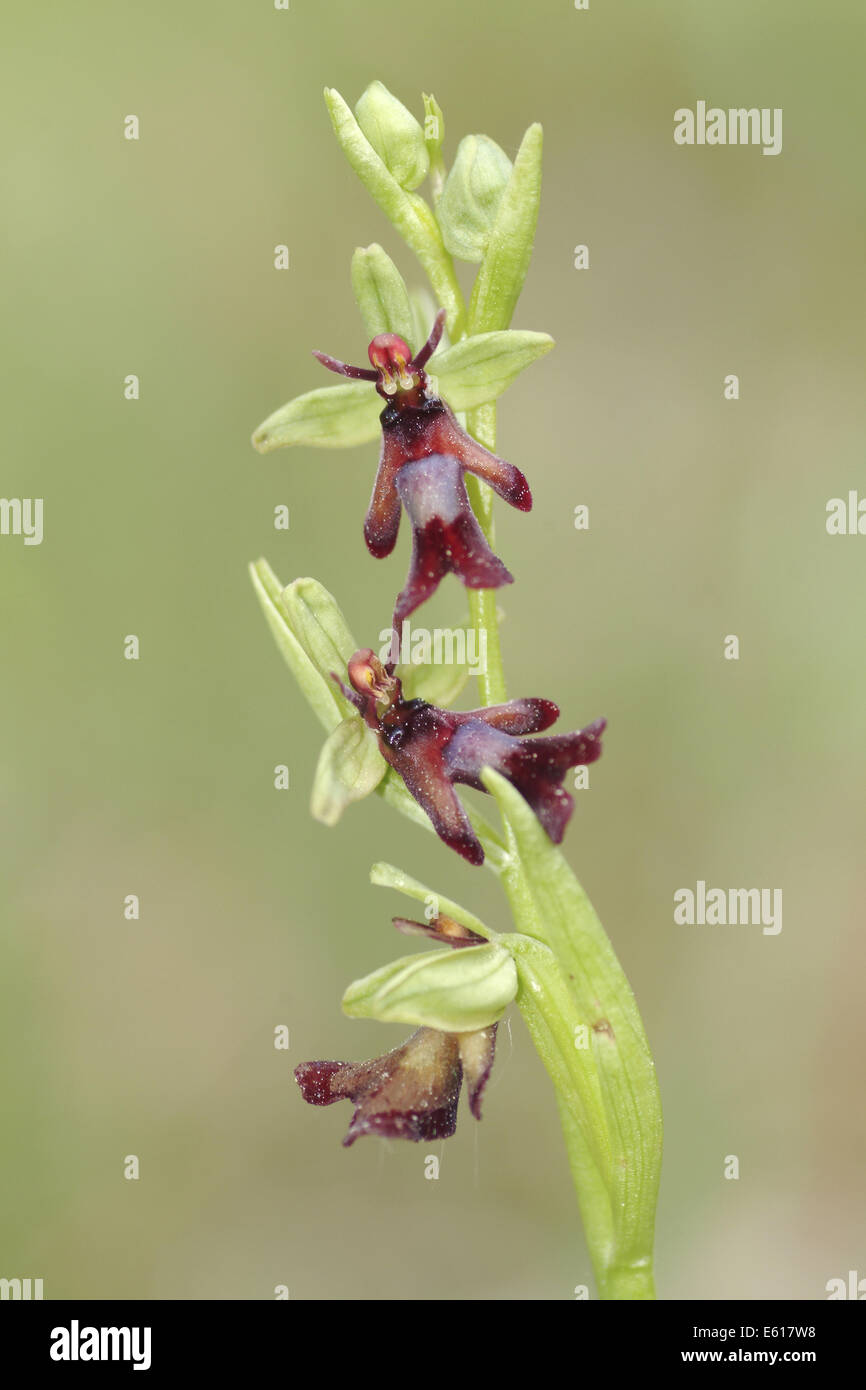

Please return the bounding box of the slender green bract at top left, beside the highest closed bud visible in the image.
[325,88,466,336]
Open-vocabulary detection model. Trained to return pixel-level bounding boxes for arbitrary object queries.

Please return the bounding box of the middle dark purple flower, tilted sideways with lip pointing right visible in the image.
[335,648,606,865]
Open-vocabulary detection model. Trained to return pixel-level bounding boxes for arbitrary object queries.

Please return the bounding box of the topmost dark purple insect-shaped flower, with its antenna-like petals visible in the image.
[313,310,532,627]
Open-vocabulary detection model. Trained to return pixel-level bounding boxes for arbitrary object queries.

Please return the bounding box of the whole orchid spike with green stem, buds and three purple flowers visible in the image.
[250,82,662,1298]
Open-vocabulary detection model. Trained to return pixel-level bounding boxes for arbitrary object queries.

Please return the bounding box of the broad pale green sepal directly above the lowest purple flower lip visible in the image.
[343,942,517,1033]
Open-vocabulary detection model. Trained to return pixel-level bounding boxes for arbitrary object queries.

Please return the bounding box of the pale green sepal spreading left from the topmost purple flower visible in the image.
[253,381,382,453]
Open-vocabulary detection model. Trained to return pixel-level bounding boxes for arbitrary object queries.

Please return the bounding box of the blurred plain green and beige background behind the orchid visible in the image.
[0,0,866,1300]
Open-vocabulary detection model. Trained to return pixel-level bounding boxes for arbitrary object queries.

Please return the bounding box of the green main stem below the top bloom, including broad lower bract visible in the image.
[467,404,662,1300]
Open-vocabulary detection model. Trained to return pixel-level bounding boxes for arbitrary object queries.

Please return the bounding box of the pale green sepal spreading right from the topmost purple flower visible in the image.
[430,329,553,410]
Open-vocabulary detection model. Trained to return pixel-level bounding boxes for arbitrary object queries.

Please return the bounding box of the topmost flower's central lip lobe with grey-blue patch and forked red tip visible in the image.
[393,453,512,631]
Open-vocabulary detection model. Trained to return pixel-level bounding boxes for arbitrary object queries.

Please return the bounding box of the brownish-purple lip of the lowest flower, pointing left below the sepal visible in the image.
[295,1023,496,1147]
